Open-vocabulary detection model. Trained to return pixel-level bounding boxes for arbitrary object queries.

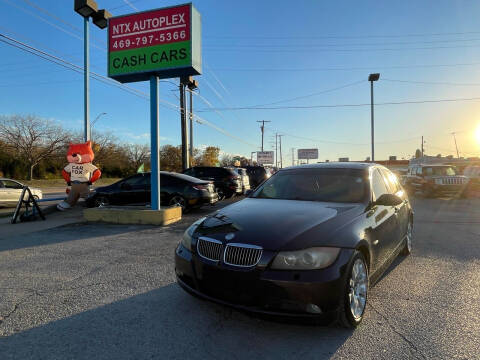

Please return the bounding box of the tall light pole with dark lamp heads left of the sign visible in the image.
[74,0,112,142]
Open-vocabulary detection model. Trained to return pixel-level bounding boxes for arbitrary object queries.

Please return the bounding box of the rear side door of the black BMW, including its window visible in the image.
[380,169,410,251]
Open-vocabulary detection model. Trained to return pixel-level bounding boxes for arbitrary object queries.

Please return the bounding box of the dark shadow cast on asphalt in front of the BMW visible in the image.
[0,283,352,359]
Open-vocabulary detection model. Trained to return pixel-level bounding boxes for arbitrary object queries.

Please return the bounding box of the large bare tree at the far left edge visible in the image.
[0,115,68,180]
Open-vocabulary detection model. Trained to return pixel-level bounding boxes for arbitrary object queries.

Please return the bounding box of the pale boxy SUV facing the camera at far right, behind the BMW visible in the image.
[404,165,468,197]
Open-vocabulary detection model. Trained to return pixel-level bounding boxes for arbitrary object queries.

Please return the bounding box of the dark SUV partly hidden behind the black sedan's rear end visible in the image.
[183,166,242,199]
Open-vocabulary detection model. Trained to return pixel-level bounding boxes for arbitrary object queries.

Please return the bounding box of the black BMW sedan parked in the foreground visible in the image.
[175,163,413,327]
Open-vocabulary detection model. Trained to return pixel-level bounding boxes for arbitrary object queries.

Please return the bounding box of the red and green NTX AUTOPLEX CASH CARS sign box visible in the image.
[108,4,202,83]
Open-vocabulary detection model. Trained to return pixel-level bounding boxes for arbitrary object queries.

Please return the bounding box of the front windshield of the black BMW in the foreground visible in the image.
[252,168,368,203]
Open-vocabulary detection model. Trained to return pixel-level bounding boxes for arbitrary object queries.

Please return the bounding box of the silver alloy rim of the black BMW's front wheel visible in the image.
[348,259,368,320]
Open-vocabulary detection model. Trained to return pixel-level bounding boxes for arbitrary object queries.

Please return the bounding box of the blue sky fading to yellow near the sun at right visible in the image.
[0,0,480,165]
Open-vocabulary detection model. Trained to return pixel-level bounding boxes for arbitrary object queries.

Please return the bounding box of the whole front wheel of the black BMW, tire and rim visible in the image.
[338,250,369,328]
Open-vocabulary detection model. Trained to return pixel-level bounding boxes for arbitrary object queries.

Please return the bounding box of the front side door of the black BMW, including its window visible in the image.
[369,168,399,270]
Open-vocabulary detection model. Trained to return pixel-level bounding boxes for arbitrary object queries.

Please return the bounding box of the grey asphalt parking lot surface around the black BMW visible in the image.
[0,198,480,360]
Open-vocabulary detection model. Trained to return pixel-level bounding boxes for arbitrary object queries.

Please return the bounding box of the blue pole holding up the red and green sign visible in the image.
[150,75,160,210]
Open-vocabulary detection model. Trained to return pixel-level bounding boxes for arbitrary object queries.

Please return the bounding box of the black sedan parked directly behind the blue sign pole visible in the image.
[86,171,218,210]
